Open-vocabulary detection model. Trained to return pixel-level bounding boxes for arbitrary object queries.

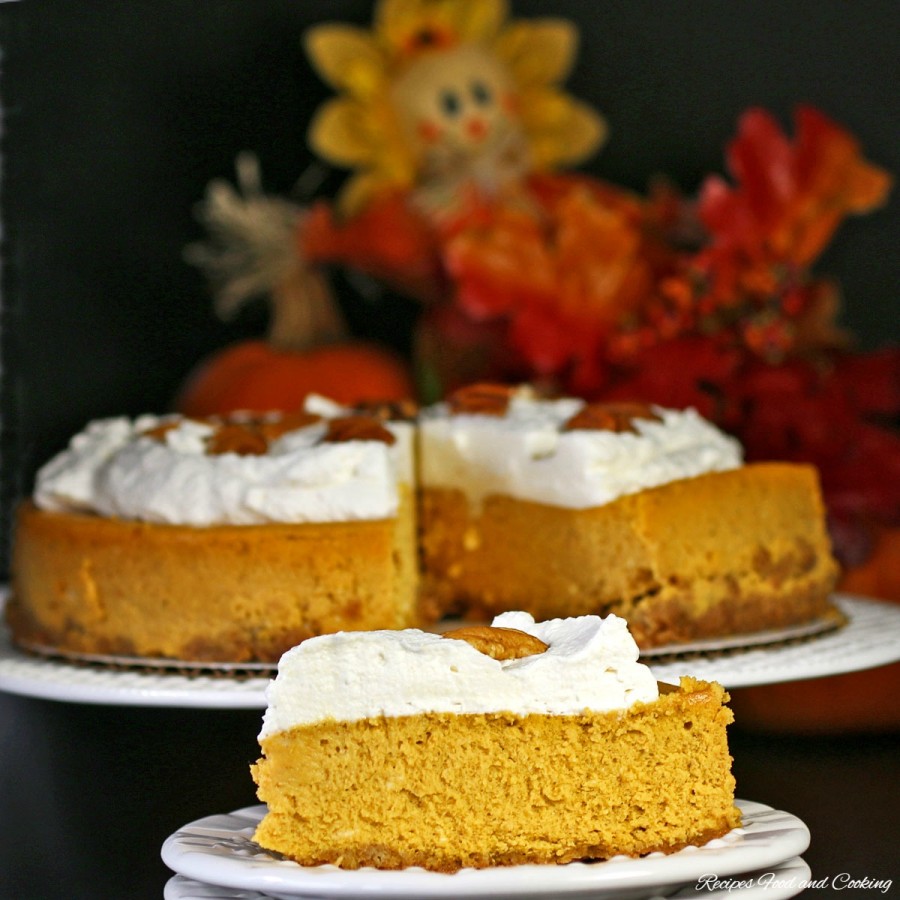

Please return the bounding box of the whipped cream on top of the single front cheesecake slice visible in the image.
[259,612,659,740]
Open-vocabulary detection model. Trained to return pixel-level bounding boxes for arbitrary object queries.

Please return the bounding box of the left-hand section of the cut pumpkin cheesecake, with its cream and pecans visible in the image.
[7,398,419,663]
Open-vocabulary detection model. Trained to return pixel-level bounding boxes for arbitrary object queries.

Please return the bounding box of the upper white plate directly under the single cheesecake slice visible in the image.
[162,800,809,900]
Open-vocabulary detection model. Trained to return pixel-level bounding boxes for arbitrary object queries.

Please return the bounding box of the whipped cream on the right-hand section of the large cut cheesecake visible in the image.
[419,389,743,509]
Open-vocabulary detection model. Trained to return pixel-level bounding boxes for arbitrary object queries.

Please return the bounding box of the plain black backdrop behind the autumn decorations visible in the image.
[0,0,900,568]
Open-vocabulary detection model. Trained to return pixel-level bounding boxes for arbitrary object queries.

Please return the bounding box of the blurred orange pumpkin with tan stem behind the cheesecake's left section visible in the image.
[175,260,415,417]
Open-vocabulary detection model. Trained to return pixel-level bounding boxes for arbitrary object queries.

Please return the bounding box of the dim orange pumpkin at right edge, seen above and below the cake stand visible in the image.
[731,528,900,734]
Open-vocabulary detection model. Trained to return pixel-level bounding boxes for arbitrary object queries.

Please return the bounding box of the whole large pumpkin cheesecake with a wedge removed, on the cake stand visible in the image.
[7,385,837,662]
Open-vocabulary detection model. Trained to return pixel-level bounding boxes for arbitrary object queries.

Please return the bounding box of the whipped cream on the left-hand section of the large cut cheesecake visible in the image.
[34,397,413,526]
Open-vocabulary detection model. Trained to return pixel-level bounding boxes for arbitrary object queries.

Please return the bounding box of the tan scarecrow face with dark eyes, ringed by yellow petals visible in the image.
[392,44,527,180]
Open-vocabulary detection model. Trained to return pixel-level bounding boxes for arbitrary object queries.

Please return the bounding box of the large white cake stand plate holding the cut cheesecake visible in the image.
[0,595,900,709]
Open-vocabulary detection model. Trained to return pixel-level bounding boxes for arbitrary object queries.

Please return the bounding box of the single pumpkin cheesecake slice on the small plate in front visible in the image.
[252,613,740,872]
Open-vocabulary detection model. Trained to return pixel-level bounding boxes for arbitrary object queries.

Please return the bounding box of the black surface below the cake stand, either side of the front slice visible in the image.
[0,693,900,900]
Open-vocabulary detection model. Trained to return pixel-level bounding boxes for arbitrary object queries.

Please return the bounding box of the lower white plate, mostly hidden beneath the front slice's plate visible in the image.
[163,856,812,900]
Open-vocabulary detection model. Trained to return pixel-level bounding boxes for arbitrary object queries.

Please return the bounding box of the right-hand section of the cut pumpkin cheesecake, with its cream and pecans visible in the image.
[419,385,838,648]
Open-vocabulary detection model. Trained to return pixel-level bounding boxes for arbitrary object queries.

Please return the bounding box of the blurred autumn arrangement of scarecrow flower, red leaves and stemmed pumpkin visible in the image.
[180,0,900,563]
